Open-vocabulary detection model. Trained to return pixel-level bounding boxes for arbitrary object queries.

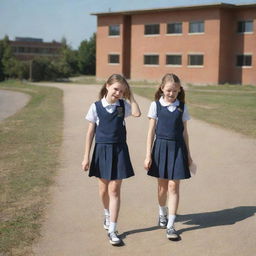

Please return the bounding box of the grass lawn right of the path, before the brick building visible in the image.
[133,85,256,138]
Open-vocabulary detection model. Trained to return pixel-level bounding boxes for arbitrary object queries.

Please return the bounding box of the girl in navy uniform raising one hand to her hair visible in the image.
[82,74,141,245]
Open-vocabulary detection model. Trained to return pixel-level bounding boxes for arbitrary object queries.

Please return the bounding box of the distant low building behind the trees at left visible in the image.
[10,37,61,61]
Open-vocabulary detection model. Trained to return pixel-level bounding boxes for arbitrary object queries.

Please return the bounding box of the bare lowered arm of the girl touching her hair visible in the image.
[82,122,95,171]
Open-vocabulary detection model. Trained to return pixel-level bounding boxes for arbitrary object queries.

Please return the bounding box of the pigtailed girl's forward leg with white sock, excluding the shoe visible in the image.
[167,180,180,229]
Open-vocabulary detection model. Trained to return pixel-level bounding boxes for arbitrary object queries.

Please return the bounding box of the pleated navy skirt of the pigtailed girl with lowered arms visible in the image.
[148,139,190,180]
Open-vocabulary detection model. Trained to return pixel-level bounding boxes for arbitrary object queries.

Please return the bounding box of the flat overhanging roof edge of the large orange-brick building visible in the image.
[91,2,256,16]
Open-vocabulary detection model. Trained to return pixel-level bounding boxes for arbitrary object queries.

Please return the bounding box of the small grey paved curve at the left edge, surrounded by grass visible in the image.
[0,90,30,121]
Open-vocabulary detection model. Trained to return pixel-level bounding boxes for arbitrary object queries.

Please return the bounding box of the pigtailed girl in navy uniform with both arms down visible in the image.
[144,74,192,239]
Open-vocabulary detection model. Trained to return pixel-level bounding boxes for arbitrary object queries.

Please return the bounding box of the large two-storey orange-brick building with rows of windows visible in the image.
[93,3,256,85]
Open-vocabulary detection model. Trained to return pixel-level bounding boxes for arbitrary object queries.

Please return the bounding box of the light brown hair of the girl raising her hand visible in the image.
[99,74,131,100]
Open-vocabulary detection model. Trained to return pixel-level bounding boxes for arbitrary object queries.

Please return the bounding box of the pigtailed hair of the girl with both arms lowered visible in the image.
[155,73,185,103]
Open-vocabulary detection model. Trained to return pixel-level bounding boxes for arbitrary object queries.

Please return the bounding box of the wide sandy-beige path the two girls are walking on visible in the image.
[33,84,256,256]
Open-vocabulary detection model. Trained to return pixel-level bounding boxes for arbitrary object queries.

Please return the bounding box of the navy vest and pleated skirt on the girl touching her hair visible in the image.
[89,100,134,180]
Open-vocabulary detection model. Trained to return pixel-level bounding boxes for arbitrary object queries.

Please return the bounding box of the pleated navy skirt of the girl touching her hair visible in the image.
[89,143,134,180]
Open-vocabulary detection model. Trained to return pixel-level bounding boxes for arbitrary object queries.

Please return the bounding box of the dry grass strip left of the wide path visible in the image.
[0,81,63,256]
